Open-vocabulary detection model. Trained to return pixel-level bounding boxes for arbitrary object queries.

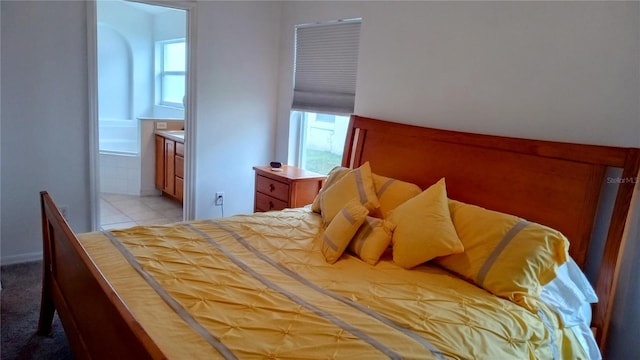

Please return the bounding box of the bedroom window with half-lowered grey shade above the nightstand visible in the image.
[291,19,361,174]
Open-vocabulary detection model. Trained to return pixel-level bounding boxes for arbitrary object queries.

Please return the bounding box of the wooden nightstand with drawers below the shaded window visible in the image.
[253,165,326,212]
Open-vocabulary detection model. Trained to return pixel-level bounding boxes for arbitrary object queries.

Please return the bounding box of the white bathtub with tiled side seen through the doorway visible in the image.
[98,118,141,195]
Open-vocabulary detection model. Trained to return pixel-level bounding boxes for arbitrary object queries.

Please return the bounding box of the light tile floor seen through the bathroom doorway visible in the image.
[100,193,182,230]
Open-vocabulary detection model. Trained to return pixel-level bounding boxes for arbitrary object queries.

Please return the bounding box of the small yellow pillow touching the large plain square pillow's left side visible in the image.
[349,216,395,265]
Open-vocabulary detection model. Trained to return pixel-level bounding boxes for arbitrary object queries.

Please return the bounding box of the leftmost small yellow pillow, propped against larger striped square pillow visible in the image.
[322,199,369,264]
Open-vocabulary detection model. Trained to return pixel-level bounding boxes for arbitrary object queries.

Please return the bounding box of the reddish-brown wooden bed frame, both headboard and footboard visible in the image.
[38,115,640,359]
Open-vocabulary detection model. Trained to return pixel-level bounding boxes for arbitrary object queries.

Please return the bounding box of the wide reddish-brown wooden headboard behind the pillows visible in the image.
[342,115,640,348]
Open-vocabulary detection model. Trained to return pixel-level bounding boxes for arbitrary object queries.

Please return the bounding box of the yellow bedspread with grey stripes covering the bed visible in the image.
[80,209,586,359]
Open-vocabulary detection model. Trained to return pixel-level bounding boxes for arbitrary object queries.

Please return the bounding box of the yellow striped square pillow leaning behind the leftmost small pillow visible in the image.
[320,162,380,224]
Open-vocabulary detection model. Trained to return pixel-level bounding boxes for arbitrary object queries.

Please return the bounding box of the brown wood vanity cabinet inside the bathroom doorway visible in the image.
[155,134,184,202]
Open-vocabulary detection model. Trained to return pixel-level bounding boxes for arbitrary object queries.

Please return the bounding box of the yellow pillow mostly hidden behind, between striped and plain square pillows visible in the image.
[371,174,422,218]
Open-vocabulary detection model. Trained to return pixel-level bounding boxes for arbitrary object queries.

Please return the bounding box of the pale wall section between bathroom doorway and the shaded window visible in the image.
[195,1,281,218]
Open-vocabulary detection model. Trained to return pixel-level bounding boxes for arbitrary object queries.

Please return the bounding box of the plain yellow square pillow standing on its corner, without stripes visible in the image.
[389,178,464,269]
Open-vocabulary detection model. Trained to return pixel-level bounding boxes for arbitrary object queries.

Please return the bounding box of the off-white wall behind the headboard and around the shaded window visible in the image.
[276,1,640,359]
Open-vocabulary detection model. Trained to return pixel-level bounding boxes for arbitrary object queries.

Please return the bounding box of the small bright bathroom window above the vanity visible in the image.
[157,39,186,108]
